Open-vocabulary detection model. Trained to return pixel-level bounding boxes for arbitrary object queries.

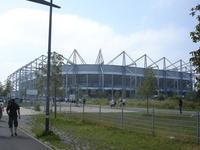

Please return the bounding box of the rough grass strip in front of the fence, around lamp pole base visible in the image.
[30,114,199,150]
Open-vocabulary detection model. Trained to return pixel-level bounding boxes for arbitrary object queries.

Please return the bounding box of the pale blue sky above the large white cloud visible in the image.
[0,0,198,34]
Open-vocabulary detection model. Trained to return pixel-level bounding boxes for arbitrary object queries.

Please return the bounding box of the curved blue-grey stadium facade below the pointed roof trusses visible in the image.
[63,64,192,94]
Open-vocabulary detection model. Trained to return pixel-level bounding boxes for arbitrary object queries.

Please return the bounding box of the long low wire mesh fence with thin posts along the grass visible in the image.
[26,103,200,144]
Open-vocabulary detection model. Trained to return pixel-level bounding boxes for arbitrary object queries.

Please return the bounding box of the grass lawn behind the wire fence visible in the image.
[83,112,196,142]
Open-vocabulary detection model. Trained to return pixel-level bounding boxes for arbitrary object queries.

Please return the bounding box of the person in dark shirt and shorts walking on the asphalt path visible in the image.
[6,99,20,136]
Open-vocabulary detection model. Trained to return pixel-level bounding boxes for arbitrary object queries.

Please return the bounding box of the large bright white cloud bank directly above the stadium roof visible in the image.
[0,9,193,80]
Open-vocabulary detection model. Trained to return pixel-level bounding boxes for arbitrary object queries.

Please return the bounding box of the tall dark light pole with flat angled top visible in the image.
[27,0,61,132]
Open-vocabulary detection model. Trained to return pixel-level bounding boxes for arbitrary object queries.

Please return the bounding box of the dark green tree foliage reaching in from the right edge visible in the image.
[190,4,200,94]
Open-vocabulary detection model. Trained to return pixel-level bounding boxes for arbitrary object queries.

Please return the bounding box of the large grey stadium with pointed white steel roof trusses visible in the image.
[7,50,194,98]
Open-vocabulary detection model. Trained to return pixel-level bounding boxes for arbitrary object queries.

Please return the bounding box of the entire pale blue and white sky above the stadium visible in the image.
[0,0,199,83]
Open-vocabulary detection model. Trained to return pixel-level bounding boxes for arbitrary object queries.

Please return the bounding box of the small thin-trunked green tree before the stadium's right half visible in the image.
[138,68,156,113]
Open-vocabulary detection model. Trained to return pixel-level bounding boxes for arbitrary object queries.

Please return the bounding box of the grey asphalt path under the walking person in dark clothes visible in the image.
[0,120,51,150]
